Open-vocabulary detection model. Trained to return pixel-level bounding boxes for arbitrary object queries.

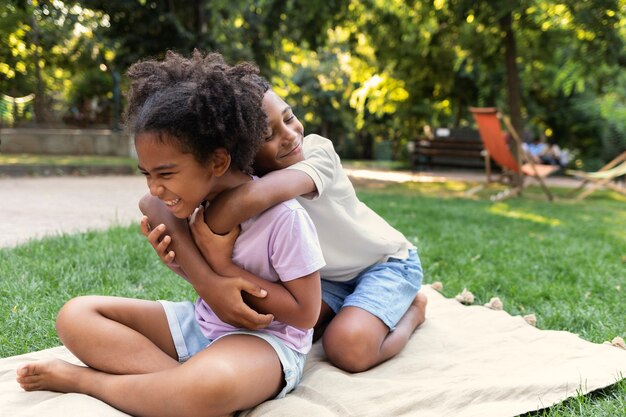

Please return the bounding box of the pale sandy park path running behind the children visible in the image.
[0,167,575,247]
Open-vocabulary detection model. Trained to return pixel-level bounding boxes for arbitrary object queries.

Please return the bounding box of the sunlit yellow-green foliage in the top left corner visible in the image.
[0,0,114,122]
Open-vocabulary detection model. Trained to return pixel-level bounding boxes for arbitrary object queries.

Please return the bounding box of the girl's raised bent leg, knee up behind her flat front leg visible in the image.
[57,296,178,374]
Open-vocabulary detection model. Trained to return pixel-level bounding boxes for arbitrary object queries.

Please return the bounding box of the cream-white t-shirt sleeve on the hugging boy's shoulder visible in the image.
[287,135,342,200]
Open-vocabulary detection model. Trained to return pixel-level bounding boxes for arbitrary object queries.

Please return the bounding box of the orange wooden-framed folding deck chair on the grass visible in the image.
[470,107,559,201]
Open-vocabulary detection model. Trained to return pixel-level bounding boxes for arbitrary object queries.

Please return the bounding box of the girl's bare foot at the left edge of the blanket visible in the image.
[16,359,88,392]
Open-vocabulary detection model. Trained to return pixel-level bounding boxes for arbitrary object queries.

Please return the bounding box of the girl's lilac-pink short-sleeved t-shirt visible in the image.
[196,200,325,353]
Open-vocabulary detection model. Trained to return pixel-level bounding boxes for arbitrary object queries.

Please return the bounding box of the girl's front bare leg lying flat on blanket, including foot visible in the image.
[17,335,283,417]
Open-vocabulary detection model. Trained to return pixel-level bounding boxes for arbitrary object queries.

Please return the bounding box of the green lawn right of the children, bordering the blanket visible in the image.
[360,182,626,417]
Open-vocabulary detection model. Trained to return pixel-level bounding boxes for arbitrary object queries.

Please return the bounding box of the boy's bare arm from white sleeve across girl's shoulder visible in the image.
[205,169,316,234]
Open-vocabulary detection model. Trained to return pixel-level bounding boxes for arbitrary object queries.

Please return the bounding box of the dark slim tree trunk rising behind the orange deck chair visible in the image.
[500,12,524,185]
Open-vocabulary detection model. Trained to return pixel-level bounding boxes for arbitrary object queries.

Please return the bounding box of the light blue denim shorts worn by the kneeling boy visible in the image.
[322,249,422,331]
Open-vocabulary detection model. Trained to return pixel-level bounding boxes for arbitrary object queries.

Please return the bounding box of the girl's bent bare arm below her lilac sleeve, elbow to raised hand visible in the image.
[190,208,321,328]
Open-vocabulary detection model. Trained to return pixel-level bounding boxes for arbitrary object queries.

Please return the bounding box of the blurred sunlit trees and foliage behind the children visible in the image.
[0,0,626,169]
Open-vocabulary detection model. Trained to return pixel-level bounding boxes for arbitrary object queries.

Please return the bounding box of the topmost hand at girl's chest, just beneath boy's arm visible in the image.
[189,206,239,269]
